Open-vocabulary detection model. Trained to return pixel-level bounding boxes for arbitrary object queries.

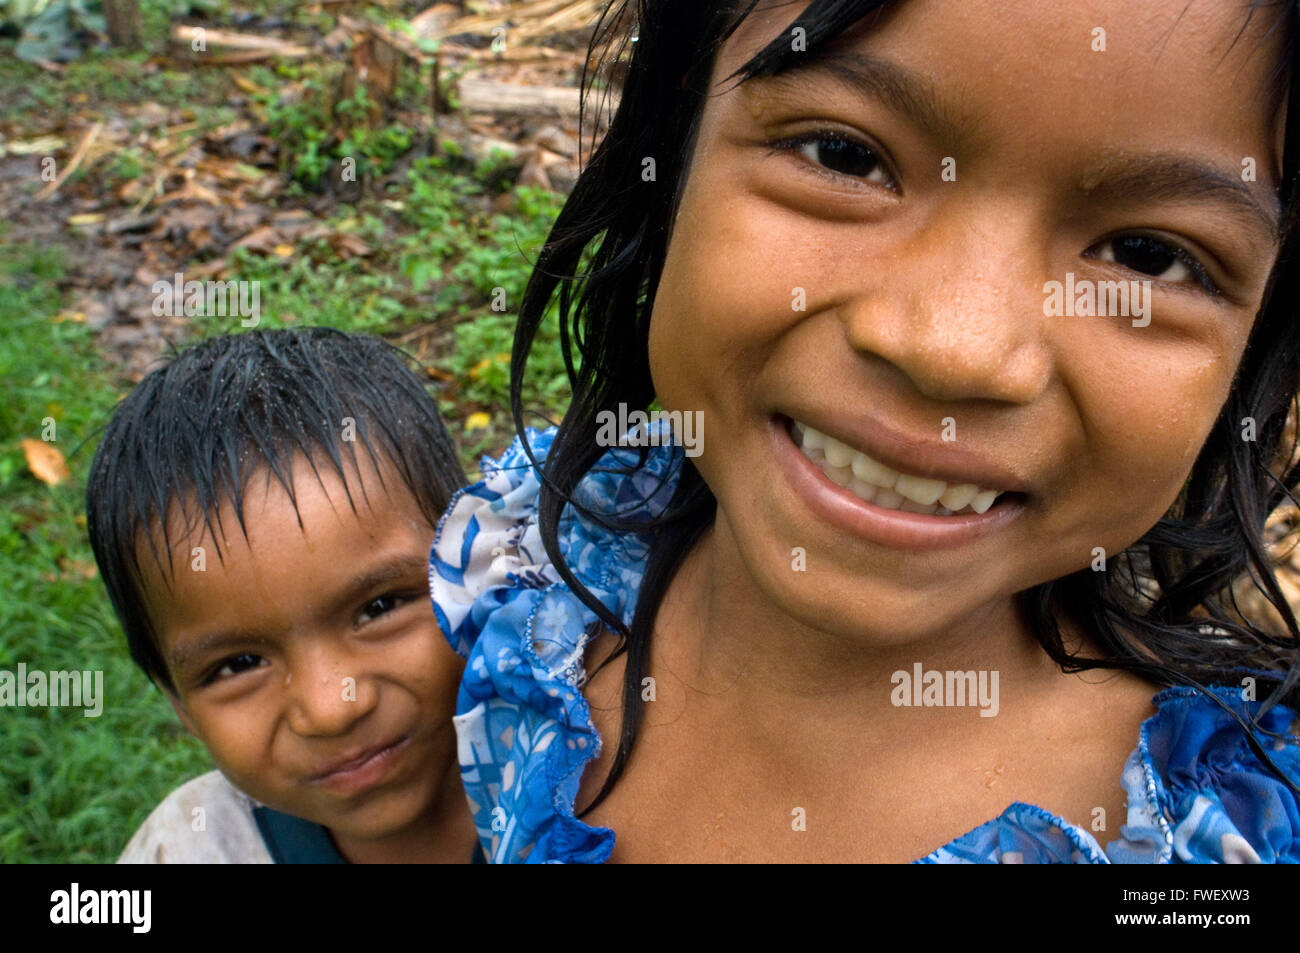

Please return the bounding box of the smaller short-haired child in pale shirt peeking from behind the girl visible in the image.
[87,328,476,863]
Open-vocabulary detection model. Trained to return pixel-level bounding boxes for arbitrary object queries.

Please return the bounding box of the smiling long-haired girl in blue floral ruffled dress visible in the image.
[432,0,1300,863]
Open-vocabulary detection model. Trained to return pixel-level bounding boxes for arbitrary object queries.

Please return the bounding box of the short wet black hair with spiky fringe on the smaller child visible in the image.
[86,328,465,692]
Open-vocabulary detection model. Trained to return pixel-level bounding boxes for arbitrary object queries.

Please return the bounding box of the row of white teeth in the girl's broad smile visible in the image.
[787,419,1021,516]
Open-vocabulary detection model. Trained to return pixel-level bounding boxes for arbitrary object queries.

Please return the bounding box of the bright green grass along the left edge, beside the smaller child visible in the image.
[0,239,211,863]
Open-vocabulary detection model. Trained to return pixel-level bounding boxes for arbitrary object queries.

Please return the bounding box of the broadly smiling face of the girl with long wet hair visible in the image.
[650,0,1281,642]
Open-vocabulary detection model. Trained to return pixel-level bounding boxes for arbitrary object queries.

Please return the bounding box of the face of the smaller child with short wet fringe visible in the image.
[143,451,462,842]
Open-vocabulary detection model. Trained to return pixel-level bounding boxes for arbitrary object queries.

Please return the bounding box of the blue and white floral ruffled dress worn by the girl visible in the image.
[429,428,1300,863]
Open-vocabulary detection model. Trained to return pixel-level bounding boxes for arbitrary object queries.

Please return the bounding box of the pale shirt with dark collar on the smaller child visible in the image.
[117,771,347,863]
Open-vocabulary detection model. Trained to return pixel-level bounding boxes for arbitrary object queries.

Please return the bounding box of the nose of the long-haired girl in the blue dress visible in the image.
[845,199,1052,404]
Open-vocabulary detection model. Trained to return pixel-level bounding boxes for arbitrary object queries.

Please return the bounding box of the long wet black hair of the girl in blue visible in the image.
[511,0,1300,813]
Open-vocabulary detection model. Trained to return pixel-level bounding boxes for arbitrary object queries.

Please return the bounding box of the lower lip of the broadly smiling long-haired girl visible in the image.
[770,419,1024,551]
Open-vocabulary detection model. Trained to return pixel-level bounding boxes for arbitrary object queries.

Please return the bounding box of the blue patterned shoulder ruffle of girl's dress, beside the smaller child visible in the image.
[429,429,683,863]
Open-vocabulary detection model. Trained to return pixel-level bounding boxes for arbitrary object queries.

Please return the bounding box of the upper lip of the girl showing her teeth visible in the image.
[788,413,1027,493]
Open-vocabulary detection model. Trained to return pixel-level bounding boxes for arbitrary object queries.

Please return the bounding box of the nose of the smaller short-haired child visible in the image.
[285,636,378,737]
